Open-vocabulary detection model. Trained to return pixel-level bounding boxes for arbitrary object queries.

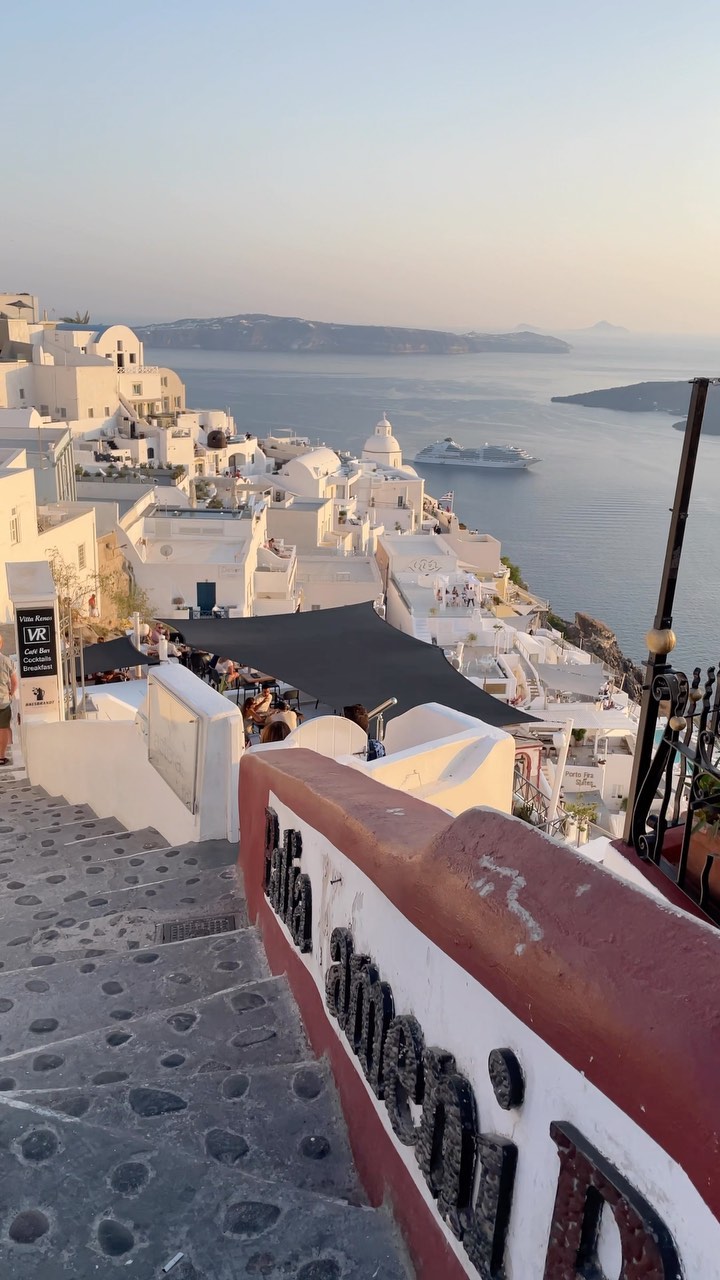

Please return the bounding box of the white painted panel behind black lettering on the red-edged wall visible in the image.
[270,794,720,1280]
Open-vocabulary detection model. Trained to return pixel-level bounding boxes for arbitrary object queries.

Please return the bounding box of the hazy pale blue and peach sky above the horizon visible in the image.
[0,0,720,333]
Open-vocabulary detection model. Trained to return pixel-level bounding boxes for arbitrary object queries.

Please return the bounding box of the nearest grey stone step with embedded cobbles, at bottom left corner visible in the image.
[0,1102,409,1280]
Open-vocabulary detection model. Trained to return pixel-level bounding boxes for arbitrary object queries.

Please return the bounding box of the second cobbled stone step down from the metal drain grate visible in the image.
[0,972,307,1095]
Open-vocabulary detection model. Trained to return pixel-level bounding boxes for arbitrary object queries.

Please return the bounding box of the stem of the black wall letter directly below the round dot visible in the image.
[462,1134,518,1280]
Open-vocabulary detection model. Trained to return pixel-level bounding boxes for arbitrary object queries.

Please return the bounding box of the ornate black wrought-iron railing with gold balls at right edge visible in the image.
[630,667,720,924]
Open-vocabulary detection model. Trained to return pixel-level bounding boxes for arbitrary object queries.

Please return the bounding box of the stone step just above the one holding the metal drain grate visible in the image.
[0,840,237,919]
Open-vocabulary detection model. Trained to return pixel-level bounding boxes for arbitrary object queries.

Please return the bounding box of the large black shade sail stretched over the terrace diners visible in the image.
[165,603,534,727]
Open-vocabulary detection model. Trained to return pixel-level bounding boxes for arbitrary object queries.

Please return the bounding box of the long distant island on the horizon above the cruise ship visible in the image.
[133,315,570,356]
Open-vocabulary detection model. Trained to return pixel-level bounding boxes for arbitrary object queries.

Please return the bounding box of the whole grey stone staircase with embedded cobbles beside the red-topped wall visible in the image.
[0,777,413,1280]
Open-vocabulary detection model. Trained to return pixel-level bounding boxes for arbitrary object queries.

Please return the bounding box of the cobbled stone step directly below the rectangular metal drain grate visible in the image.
[0,929,268,1054]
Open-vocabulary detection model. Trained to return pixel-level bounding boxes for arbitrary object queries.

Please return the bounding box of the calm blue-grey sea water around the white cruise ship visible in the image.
[146,337,720,667]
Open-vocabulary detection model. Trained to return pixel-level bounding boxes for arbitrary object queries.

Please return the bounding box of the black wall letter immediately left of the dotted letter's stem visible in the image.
[415,1048,478,1239]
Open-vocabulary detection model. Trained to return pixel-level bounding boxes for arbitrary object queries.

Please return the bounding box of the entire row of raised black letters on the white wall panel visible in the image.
[264,809,683,1280]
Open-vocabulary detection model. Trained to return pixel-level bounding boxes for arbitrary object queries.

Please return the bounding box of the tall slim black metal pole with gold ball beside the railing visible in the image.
[623,378,714,844]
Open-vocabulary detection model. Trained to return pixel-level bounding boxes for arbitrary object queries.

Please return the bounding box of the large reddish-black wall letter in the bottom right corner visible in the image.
[544,1123,683,1280]
